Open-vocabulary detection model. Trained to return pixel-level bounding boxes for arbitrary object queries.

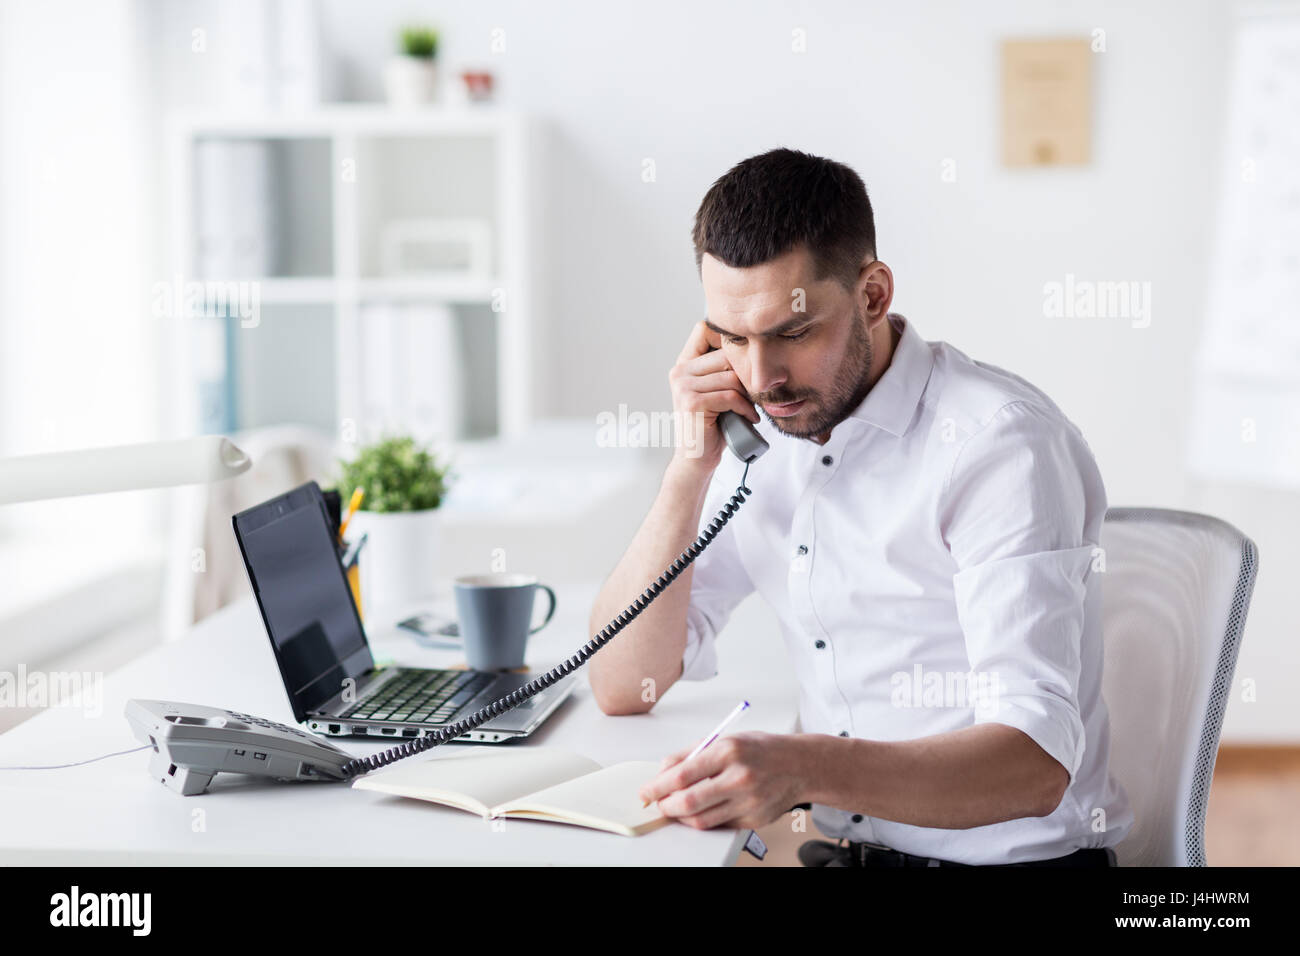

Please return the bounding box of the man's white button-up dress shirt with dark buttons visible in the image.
[683,315,1132,864]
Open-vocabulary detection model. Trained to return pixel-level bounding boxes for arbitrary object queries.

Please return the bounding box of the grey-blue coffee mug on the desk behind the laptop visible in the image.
[455,574,555,671]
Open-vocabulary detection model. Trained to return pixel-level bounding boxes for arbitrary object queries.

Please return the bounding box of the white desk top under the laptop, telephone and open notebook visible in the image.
[0,584,797,866]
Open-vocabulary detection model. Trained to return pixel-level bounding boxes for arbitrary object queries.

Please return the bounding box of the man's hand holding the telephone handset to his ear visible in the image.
[668,320,761,475]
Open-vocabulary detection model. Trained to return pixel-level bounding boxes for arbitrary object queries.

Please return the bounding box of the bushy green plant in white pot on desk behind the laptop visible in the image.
[338,436,450,610]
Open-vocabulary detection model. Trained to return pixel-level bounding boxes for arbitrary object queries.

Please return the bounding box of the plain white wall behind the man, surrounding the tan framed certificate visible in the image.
[154,0,1300,740]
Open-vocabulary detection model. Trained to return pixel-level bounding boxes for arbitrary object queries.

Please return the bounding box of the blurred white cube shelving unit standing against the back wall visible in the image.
[166,105,536,440]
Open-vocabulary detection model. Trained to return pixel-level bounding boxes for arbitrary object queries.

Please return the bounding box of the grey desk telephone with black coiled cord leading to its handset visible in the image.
[126,411,768,796]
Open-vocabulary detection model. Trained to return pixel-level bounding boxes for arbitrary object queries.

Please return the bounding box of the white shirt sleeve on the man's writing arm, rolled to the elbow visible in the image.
[941,402,1105,784]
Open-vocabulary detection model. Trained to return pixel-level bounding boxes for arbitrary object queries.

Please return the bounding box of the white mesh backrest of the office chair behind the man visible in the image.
[1101,507,1258,866]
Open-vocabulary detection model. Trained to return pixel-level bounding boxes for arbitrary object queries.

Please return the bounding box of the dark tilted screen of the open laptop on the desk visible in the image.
[234,481,374,721]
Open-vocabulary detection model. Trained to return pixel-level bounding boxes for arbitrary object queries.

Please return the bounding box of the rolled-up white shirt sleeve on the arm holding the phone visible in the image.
[681,473,754,680]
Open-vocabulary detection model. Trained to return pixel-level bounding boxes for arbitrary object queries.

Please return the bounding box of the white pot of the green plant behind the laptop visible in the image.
[347,509,438,619]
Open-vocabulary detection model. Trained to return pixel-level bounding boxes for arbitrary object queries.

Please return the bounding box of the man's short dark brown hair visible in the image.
[692,148,876,289]
